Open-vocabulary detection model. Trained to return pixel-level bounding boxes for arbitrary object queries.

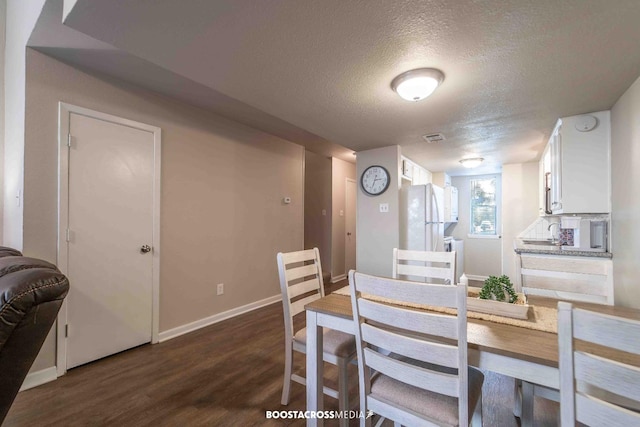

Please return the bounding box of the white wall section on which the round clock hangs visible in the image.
[356,145,401,277]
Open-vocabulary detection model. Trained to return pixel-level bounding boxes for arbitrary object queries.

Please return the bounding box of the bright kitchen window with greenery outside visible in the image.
[469,176,500,237]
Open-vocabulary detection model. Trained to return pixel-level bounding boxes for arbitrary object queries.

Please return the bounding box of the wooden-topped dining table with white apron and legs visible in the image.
[305,293,640,427]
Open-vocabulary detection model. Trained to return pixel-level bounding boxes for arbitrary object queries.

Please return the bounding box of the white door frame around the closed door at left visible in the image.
[56,102,162,377]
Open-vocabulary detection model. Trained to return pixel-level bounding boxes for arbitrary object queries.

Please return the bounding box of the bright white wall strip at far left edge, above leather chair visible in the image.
[3,0,45,249]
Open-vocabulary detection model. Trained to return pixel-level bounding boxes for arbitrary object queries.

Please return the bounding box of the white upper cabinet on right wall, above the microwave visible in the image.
[552,111,611,214]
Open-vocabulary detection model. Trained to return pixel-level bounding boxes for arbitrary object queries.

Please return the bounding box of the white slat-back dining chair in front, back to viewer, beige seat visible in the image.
[349,270,484,426]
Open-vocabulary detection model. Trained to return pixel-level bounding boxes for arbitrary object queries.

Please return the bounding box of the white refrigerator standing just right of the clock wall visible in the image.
[400,184,445,252]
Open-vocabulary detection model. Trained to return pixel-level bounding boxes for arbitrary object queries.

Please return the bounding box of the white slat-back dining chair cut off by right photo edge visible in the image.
[558,302,640,427]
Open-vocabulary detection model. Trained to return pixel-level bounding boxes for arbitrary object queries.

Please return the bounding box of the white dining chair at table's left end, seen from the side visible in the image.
[277,248,356,422]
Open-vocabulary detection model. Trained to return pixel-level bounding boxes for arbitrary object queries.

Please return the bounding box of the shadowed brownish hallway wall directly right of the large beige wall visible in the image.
[304,151,332,280]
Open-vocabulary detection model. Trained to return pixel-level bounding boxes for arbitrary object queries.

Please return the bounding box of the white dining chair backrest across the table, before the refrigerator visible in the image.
[393,248,456,285]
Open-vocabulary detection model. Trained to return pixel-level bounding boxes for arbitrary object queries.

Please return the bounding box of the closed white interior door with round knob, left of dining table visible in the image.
[61,112,155,368]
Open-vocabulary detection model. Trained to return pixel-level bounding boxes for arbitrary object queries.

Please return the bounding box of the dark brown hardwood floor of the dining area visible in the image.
[3,281,558,427]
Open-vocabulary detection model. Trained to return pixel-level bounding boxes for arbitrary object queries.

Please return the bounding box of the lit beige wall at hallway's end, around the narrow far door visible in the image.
[331,157,358,278]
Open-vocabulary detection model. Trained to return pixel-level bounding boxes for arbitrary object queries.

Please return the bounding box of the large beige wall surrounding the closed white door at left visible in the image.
[24,49,304,368]
